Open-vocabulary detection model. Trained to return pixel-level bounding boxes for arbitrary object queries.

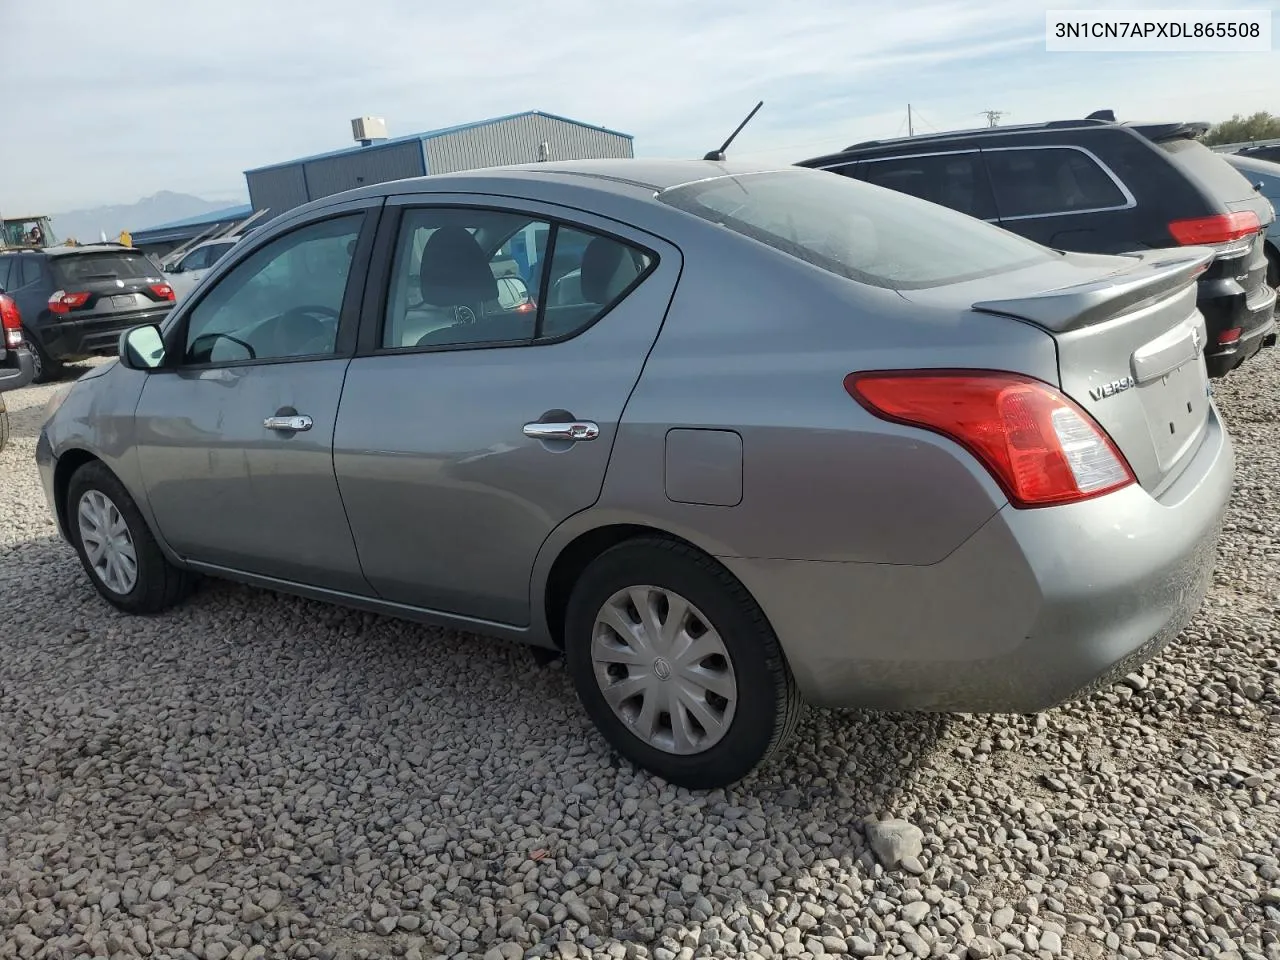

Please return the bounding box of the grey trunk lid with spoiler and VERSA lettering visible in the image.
[902,247,1213,495]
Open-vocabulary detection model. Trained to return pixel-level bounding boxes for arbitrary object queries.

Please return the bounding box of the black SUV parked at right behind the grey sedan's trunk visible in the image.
[799,118,1276,376]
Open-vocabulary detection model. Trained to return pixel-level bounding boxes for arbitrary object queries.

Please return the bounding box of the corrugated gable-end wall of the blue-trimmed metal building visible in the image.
[424,115,632,173]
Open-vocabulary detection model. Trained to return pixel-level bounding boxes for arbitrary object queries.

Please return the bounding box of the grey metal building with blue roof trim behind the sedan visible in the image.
[244,110,635,216]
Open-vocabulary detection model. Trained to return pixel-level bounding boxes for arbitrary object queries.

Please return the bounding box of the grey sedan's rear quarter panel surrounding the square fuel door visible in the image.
[577,224,1056,563]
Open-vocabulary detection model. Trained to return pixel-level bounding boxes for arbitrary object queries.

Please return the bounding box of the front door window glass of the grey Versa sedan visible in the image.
[184,214,364,364]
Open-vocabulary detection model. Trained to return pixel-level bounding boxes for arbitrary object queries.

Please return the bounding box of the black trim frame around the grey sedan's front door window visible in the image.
[161,204,383,374]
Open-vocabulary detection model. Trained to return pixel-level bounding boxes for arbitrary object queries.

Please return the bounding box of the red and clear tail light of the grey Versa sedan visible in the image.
[845,370,1135,507]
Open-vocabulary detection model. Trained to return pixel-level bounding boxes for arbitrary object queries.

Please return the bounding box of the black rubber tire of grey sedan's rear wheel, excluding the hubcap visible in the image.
[564,541,785,788]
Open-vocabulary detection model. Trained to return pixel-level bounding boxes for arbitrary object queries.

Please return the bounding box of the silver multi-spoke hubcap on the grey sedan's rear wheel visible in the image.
[591,586,737,755]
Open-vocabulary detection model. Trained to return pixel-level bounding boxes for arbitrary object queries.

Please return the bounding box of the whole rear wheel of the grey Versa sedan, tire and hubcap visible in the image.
[564,538,803,790]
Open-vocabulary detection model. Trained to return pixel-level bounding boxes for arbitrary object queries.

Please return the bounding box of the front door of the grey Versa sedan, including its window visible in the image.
[136,207,376,594]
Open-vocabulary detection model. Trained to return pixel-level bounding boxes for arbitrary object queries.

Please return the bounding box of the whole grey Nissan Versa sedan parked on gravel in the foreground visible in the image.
[36,160,1234,788]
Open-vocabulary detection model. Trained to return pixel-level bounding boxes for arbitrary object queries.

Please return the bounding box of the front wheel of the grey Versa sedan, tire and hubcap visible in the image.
[67,461,195,613]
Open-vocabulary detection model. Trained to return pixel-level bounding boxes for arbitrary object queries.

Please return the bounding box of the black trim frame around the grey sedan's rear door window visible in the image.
[356,200,662,357]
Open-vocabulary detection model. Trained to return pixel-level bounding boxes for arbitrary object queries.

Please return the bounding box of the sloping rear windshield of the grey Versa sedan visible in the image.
[658,169,1056,289]
